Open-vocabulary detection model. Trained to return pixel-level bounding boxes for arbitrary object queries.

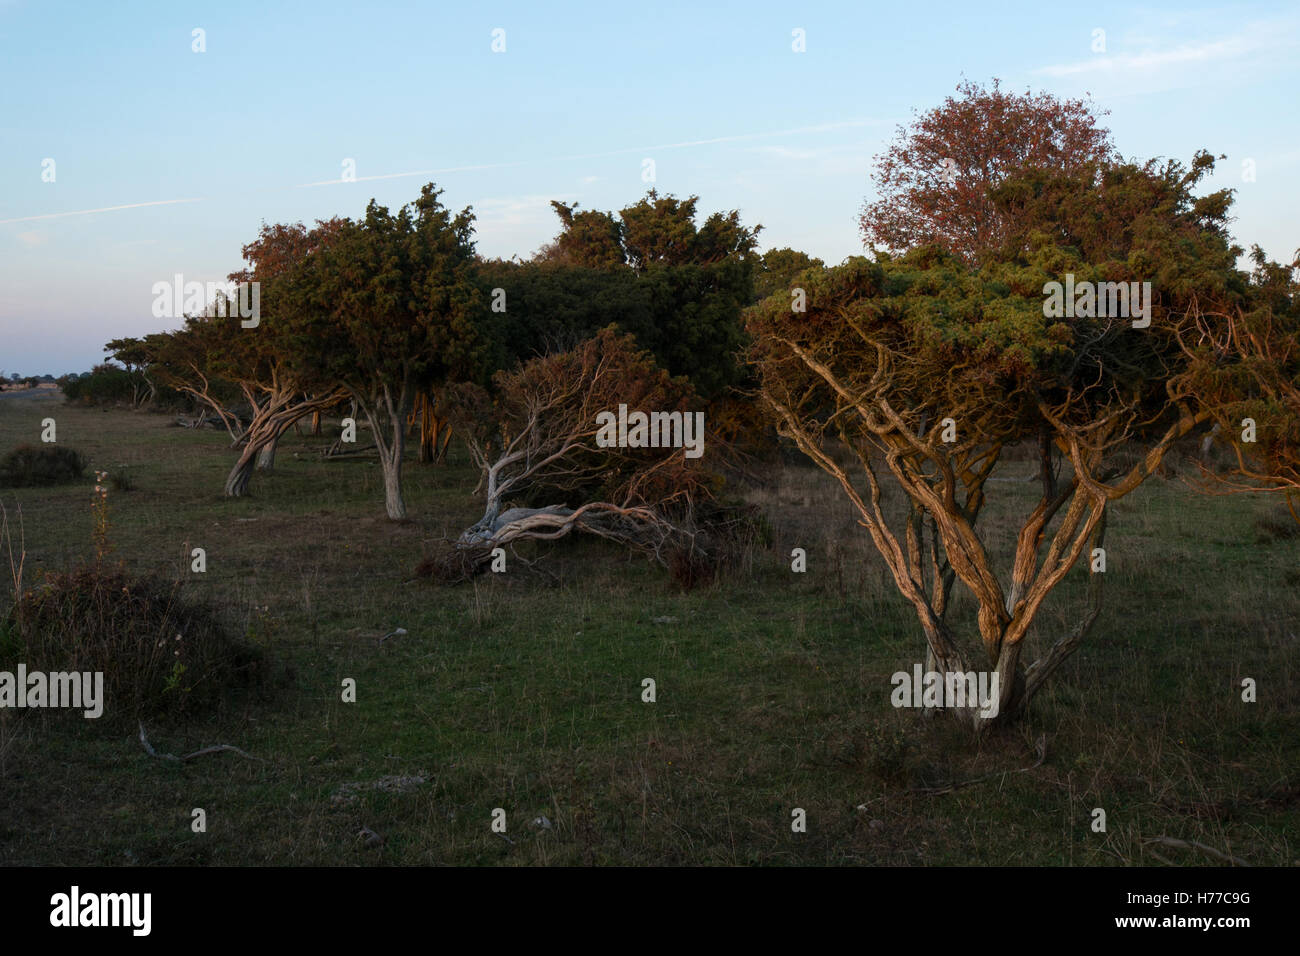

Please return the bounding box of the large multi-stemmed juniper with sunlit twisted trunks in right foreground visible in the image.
[749,153,1242,727]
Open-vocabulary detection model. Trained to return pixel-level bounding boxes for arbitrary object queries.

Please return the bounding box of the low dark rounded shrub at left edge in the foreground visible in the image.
[0,563,264,721]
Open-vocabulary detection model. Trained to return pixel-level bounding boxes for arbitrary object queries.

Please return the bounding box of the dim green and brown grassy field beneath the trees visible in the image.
[0,395,1300,865]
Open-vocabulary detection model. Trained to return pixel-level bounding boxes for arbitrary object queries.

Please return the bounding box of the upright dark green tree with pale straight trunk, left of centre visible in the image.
[293,183,484,520]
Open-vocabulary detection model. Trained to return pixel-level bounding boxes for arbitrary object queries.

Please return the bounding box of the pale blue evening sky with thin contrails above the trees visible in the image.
[0,0,1300,376]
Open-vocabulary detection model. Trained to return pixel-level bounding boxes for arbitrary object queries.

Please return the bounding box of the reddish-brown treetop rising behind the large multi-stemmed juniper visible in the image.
[858,79,1114,261]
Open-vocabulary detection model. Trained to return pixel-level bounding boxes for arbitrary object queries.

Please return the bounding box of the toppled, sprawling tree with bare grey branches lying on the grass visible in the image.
[445,328,714,580]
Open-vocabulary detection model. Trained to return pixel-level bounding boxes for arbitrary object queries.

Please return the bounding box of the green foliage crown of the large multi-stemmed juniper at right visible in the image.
[749,153,1245,455]
